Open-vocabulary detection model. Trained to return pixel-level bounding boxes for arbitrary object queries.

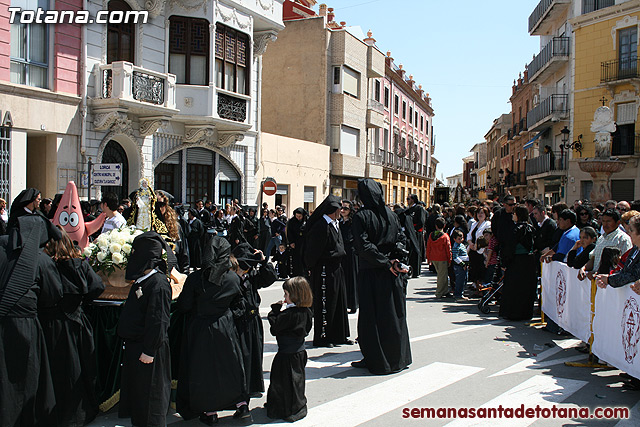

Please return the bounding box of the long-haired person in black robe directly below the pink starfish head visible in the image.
[38,226,105,427]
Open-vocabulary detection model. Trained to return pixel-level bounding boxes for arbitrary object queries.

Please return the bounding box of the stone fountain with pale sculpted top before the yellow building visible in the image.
[578,106,626,204]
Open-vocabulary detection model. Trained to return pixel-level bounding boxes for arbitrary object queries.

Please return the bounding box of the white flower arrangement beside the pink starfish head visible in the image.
[82,226,143,276]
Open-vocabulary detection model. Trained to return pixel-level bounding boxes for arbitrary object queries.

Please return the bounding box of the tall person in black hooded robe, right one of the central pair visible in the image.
[352,179,411,374]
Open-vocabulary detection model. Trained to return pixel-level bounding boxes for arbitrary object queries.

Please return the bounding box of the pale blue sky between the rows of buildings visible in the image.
[328,0,540,179]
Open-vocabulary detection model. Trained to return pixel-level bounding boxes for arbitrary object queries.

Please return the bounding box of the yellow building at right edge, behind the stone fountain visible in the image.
[567,0,640,202]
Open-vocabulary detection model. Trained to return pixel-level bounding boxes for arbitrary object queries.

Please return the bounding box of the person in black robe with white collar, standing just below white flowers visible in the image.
[118,231,175,427]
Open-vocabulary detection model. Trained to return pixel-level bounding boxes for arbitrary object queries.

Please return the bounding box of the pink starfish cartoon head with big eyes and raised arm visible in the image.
[53,181,106,249]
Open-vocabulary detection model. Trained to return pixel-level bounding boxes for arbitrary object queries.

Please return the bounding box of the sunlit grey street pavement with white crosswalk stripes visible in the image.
[90,270,640,427]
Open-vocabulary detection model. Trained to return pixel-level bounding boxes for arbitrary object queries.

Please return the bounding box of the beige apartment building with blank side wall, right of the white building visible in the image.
[262,5,385,199]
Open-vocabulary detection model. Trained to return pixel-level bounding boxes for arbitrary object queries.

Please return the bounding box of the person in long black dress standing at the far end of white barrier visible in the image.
[500,206,538,320]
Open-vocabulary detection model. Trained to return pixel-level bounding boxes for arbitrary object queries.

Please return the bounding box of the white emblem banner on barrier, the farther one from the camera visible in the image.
[542,261,591,342]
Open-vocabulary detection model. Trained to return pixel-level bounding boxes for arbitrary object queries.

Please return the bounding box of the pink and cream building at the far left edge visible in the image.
[0,0,83,200]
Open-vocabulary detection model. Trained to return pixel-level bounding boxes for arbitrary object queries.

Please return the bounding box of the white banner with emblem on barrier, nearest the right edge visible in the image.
[592,286,640,378]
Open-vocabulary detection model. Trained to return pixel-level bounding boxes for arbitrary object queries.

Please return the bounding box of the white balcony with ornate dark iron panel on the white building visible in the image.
[99,61,176,109]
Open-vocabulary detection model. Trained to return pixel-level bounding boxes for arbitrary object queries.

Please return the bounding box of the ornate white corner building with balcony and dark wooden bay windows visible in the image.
[80,0,284,204]
